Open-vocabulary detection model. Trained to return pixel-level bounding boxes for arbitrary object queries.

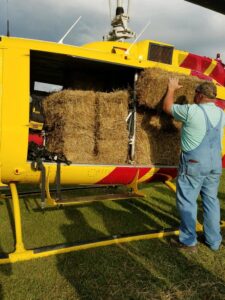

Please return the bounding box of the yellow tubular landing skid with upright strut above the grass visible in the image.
[0,183,225,264]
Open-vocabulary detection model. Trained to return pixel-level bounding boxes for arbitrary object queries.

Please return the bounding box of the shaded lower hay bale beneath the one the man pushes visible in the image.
[135,110,180,166]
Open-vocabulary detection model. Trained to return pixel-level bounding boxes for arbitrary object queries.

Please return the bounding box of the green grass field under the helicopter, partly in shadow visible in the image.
[0,173,225,300]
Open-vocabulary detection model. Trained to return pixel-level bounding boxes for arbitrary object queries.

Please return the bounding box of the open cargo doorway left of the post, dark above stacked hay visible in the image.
[28,50,140,165]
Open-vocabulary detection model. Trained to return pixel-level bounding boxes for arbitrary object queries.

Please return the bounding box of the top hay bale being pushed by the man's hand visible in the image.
[137,68,203,109]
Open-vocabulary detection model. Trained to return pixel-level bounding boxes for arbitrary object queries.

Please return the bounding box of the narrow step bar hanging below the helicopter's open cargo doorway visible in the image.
[55,193,143,205]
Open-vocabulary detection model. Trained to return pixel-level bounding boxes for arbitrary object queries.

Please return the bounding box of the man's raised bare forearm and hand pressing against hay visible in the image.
[163,78,182,115]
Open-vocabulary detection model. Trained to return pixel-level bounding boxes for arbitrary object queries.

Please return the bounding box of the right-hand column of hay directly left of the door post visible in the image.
[95,91,129,164]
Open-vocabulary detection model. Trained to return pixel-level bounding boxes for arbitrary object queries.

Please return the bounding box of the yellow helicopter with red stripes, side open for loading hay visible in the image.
[0,0,225,264]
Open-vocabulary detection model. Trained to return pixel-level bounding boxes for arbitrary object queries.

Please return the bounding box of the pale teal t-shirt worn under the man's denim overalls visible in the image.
[171,102,225,152]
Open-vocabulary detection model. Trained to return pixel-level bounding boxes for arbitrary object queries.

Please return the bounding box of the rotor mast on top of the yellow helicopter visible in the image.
[105,0,135,41]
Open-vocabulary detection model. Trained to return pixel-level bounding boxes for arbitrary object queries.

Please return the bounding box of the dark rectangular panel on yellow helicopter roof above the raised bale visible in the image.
[148,43,173,65]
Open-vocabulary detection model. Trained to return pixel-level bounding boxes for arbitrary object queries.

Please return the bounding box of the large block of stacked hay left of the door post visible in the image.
[43,90,129,164]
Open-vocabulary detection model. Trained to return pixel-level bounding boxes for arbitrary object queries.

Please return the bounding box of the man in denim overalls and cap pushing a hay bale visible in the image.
[163,78,225,251]
